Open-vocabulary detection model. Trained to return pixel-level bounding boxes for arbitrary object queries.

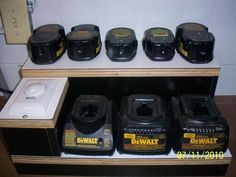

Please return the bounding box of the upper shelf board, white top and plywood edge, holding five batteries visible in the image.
[21,43,220,77]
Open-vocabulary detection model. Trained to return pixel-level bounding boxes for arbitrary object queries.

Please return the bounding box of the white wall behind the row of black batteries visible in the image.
[0,0,236,95]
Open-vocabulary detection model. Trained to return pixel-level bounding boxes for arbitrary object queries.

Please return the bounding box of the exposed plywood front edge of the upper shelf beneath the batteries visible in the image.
[21,68,220,77]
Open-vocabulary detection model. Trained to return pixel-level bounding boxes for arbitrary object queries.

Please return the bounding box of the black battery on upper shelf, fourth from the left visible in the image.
[142,27,175,61]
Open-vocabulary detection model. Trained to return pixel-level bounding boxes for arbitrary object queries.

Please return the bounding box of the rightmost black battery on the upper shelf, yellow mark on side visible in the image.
[175,23,215,63]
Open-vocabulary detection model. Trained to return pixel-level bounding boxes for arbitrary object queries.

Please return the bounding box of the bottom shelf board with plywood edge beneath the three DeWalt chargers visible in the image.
[11,150,232,166]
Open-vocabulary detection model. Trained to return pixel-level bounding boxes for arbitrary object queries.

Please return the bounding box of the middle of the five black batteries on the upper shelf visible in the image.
[105,28,138,61]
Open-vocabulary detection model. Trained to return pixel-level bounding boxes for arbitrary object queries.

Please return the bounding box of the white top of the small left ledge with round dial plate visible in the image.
[0,78,67,119]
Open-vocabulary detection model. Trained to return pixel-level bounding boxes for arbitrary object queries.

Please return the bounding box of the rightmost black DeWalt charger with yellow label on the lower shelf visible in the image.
[172,95,229,153]
